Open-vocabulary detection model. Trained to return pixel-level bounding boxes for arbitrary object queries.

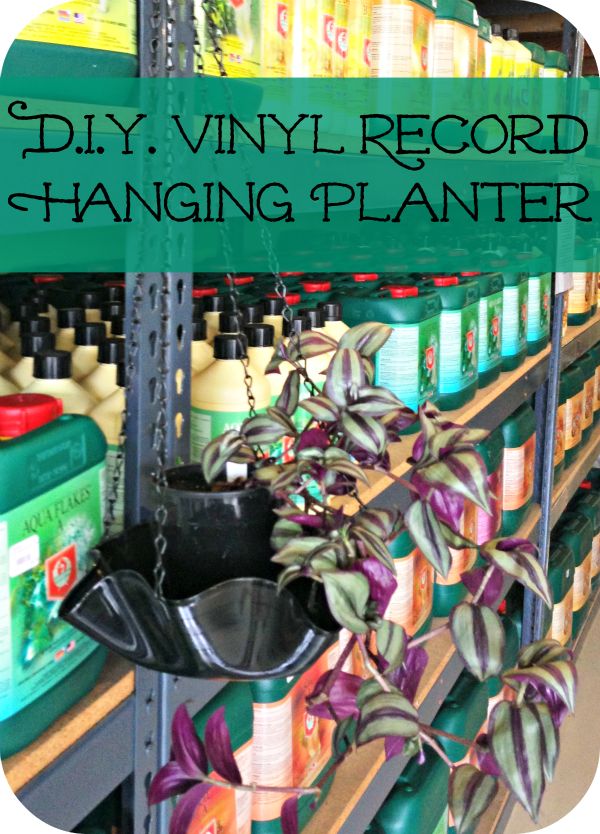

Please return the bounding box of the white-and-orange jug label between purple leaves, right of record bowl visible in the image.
[385,548,433,636]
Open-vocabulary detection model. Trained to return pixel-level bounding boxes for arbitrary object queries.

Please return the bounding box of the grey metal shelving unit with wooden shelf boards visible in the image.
[4,0,600,834]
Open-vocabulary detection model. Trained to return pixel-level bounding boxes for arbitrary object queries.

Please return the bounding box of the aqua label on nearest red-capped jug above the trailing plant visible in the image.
[375,316,440,411]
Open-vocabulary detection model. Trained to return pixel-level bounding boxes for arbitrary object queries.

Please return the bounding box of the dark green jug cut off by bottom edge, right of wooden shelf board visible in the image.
[365,749,450,834]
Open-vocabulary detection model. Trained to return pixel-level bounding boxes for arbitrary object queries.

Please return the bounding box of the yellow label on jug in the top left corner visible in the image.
[17,0,137,55]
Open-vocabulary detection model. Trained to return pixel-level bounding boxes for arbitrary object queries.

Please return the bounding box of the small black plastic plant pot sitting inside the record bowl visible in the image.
[166,464,278,595]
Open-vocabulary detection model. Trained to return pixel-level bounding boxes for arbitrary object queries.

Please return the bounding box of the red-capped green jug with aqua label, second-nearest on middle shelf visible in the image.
[433,275,479,411]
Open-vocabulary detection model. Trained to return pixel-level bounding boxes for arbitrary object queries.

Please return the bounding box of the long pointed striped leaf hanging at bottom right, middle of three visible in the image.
[488,701,546,821]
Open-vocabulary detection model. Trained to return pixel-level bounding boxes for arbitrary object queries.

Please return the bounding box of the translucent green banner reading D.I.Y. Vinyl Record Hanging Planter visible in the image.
[0,78,600,272]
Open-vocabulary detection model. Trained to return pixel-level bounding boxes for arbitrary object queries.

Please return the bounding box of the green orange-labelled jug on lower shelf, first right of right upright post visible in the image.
[543,538,575,646]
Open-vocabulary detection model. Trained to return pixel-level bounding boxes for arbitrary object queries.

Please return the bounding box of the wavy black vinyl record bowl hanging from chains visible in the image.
[60,524,337,680]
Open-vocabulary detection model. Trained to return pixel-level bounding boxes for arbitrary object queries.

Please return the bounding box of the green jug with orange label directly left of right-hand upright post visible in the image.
[501,403,535,536]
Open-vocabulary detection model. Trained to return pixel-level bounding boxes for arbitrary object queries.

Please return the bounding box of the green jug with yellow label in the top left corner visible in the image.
[2,0,138,78]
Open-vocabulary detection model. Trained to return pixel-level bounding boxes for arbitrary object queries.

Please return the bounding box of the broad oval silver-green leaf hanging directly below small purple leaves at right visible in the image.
[450,602,505,681]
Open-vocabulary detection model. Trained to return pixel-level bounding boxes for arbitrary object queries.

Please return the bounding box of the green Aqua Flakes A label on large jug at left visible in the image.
[0,463,104,721]
